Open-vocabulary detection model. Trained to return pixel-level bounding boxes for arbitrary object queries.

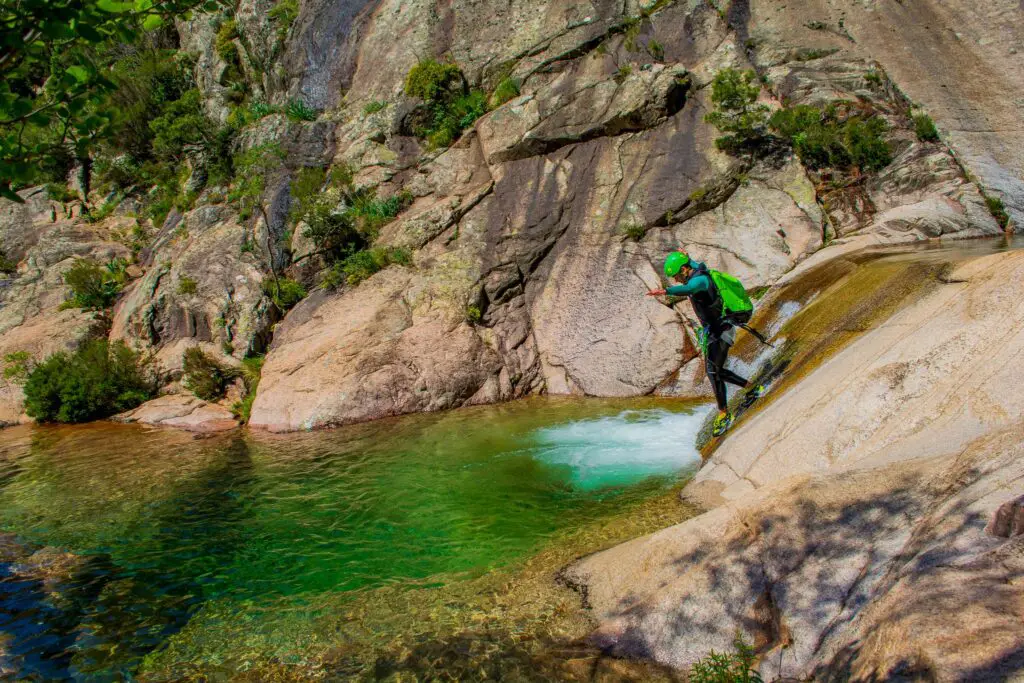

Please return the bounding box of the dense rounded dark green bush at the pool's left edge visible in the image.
[25,340,157,423]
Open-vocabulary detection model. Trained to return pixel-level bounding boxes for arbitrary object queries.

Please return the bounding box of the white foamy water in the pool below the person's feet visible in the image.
[531,407,707,489]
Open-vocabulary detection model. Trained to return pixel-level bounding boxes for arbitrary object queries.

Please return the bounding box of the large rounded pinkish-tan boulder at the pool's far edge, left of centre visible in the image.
[249,267,500,431]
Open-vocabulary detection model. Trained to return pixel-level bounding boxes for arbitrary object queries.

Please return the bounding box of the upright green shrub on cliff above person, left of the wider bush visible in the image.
[705,69,768,154]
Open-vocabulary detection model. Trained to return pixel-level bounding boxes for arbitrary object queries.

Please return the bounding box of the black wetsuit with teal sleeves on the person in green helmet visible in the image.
[666,261,750,411]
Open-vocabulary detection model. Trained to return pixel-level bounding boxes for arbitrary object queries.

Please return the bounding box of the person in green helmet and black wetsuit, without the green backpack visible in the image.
[647,252,764,436]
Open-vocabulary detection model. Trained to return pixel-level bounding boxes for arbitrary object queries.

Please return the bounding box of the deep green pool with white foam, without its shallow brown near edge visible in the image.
[0,399,707,681]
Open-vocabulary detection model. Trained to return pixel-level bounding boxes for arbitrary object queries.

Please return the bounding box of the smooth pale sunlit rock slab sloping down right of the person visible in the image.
[688,251,1024,501]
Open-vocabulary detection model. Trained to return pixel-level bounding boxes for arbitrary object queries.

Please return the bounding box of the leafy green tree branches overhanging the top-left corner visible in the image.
[0,0,222,202]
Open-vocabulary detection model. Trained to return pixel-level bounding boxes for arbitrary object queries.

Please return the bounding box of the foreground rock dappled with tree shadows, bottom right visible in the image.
[566,425,1024,681]
